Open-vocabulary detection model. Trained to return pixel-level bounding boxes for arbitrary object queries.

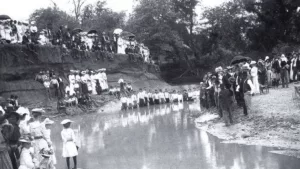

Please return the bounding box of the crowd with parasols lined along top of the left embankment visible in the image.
[0,19,150,63]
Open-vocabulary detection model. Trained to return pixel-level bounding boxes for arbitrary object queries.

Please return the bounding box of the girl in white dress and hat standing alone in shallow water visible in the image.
[61,119,78,169]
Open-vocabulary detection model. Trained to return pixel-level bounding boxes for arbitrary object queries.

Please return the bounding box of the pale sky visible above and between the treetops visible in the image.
[0,0,227,21]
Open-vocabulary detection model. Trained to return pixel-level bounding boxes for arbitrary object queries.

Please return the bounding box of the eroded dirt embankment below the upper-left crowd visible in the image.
[0,45,168,114]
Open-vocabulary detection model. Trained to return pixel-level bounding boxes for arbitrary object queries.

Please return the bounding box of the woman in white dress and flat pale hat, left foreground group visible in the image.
[29,109,48,161]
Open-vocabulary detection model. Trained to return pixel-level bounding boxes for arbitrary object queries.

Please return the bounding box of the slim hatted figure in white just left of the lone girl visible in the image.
[43,118,56,165]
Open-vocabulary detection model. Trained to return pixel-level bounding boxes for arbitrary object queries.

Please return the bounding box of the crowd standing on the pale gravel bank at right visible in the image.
[200,52,300,125]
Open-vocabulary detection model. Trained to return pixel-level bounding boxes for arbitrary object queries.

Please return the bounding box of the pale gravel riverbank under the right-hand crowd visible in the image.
[195,85,300,158]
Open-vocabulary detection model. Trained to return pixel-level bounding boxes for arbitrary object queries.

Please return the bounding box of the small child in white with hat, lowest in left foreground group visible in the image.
[19,138,38,169]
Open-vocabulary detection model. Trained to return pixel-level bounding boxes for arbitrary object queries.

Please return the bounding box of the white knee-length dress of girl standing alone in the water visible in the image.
[61,128,78,158]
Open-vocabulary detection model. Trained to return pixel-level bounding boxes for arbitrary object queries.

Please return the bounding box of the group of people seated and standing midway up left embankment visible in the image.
[35,69,108,112]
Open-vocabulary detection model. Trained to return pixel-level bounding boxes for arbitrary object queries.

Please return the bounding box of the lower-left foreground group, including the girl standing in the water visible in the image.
[0,95,78,169]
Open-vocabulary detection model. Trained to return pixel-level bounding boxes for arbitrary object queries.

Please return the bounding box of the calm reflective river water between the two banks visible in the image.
[52,102,300,169]
